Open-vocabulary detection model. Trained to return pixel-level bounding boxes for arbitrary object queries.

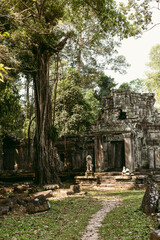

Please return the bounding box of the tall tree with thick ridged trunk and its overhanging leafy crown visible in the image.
[0,0,152,184]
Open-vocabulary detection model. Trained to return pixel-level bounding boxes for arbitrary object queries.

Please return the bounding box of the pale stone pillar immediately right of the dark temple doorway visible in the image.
[124,133,134,171]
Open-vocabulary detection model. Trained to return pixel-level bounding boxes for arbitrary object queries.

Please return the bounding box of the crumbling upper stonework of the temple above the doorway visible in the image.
[103,90,160,122]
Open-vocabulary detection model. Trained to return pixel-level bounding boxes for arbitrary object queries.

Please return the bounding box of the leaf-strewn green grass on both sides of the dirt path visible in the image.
[0,190,157,240]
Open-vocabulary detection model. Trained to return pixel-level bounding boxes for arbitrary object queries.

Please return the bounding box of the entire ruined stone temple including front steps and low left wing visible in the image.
[3,90,160,188]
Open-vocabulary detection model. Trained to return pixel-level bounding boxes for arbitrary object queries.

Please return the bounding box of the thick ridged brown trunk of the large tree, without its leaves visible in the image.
[34,49,59,184]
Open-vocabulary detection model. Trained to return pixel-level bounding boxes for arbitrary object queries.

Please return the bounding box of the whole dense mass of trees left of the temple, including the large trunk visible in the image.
[0,0,154,183]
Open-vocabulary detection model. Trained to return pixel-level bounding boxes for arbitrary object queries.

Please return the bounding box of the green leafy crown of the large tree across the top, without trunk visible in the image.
[0,0,152,129]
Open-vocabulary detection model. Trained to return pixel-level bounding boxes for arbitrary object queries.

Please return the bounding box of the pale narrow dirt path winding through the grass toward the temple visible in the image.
[80,198,121,240]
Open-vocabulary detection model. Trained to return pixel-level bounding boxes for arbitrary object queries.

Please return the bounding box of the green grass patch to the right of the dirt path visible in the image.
[96,191,157,240]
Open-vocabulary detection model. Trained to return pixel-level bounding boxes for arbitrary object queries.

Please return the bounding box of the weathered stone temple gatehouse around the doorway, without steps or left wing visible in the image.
[91,90,160,171]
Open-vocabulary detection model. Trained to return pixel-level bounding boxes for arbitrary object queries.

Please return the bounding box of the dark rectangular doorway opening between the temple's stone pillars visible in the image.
[111,141,125,171]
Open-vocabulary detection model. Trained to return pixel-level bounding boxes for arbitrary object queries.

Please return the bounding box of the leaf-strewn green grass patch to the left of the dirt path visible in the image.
[0,197,101,240]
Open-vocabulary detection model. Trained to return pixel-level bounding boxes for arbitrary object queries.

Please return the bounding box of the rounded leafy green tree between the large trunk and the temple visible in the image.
[55,69,98,136]
